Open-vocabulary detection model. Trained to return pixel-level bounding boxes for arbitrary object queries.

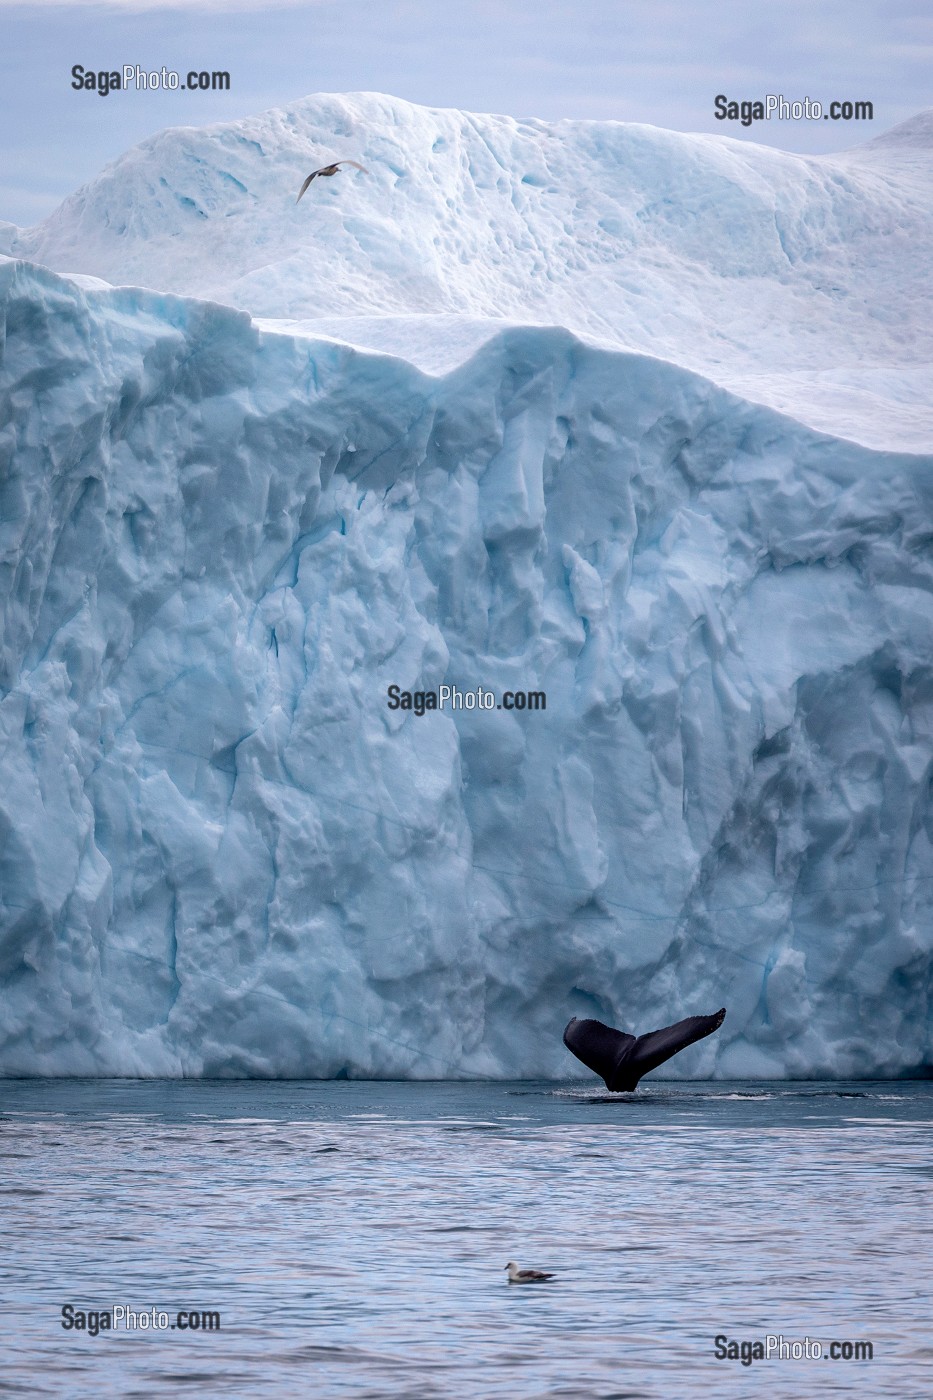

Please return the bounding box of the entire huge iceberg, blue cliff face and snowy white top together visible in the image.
[0,95,933,1078]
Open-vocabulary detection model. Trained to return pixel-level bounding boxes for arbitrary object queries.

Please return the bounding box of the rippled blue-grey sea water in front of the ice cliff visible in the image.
[0,1081,933,1400]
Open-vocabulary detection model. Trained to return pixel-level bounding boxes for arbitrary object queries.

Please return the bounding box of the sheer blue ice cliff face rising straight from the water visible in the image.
[0,99,933,1077]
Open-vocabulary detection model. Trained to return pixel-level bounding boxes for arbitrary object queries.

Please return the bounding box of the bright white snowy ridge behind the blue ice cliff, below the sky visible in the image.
[0,94,933,451]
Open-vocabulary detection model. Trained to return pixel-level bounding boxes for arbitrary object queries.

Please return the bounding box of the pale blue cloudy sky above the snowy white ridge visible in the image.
[0,0,933,225]
